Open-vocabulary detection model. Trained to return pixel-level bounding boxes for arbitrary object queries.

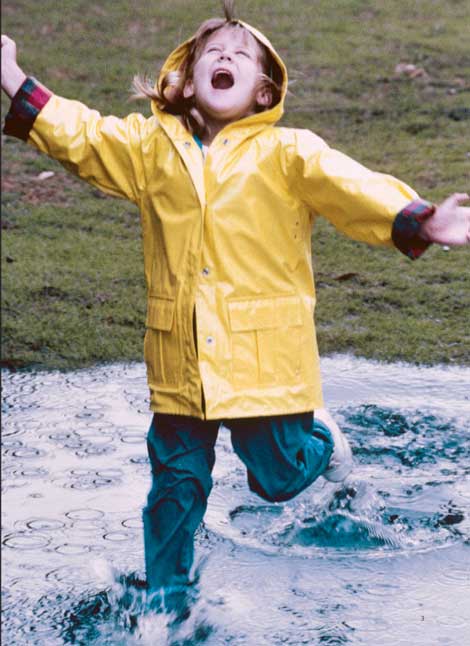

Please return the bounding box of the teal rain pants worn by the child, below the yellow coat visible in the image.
[143,412,333,591]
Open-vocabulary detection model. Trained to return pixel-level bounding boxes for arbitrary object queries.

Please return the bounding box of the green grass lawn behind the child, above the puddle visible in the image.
[2,0,470,368]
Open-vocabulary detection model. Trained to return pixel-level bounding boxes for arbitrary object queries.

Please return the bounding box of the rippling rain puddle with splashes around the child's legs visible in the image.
[2,356,470,646]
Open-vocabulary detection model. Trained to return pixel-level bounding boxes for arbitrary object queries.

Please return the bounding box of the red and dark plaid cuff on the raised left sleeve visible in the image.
[3,77,52,141]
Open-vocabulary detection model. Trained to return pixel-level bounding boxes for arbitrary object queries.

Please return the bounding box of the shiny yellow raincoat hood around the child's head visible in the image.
[152,20,288,125]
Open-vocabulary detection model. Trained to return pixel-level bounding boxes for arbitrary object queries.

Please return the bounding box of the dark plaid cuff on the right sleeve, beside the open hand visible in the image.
[392,200,436,260]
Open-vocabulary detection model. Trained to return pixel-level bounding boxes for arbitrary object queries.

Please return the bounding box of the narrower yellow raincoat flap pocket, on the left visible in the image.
[144,296,181,389]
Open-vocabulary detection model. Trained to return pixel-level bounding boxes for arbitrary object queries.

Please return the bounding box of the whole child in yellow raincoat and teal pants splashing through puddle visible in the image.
[2,3,470,608]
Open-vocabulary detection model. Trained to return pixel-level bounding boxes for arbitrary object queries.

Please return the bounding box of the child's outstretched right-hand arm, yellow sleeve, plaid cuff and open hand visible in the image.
[286,130,470,259]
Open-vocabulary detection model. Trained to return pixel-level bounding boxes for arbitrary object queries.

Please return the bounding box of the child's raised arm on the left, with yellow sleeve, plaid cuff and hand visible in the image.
[2,36,151,202]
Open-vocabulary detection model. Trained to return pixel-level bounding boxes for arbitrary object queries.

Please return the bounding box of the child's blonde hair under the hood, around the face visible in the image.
[131,0,282,137]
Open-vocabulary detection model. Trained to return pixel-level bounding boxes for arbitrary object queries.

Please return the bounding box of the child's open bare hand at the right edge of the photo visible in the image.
[420,193,470,246]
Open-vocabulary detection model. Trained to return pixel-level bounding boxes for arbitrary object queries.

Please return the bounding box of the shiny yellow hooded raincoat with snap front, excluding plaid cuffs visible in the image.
[26,20,416,419]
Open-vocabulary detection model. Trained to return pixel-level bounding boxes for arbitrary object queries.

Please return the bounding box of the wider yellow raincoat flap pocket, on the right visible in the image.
[228,296,303,388]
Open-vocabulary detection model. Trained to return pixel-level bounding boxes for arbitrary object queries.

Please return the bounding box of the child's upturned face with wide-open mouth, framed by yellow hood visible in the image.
[184,27,272,126]
